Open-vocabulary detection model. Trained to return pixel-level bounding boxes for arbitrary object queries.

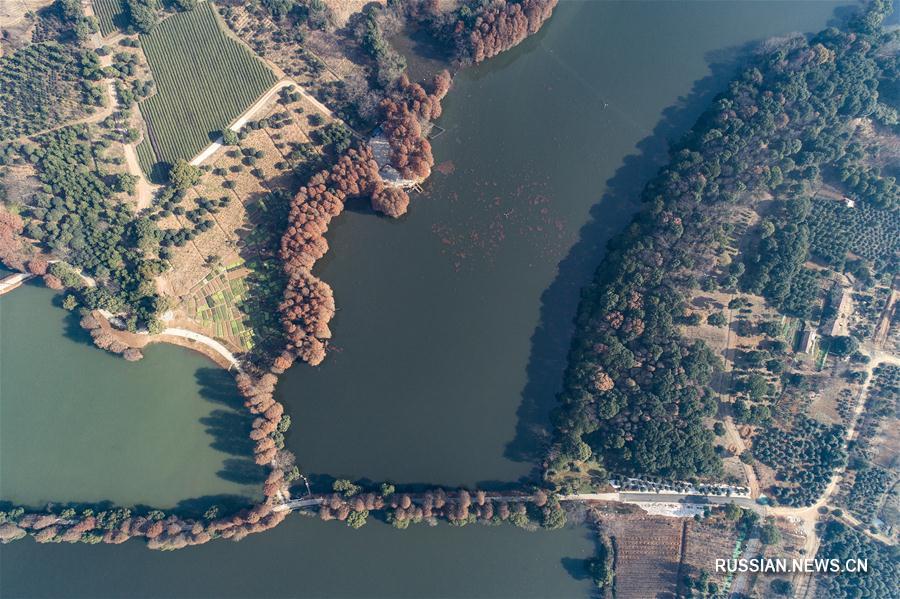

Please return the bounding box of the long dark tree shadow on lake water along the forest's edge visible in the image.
[504,42,800,477]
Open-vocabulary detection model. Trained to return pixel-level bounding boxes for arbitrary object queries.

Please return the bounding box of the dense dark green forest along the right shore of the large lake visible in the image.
[545,1,897,484]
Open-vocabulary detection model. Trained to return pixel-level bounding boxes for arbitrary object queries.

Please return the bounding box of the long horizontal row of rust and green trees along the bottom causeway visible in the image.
[0,486,566,550]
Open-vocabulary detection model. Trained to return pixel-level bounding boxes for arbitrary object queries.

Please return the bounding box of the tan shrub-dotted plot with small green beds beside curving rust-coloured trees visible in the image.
[159,96,327,351]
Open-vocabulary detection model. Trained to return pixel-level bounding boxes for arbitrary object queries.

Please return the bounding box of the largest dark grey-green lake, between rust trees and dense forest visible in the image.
[278,1,848,487]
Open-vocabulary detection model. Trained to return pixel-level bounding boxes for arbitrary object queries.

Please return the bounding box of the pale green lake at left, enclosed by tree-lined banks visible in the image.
[0,284,265,508]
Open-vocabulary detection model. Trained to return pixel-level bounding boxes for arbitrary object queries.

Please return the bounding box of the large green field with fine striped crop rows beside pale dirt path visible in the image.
[139,2,276,170]
